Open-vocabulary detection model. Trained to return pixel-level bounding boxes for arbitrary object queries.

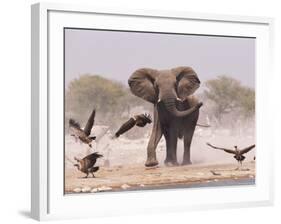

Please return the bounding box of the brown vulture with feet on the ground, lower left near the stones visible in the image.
[74,152,103,178]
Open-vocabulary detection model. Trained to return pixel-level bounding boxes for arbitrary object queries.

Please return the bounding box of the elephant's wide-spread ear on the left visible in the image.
[128,68,158,103]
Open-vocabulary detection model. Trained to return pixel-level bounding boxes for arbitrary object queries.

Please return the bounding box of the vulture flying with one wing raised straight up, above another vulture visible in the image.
[69,109,96,148]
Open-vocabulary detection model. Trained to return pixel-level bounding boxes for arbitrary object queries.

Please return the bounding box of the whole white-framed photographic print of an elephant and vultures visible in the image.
[31,3,273,220]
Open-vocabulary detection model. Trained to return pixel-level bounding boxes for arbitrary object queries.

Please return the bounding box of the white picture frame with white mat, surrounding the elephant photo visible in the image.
[31,3,273,220]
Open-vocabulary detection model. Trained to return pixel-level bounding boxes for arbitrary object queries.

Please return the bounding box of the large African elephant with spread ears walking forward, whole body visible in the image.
[128,67,202,166]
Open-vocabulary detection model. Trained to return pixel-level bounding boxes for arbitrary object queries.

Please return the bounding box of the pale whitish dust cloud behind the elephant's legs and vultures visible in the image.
[65,111,256,169]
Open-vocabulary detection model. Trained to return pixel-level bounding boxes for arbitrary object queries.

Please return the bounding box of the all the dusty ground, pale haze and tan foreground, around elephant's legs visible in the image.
[65,126,256,193]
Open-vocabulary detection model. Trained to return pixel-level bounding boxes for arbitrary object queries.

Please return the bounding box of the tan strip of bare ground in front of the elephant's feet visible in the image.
[65,161,255,193]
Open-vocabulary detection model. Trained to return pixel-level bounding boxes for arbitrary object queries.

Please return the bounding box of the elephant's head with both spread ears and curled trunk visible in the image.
[128,67,202,117]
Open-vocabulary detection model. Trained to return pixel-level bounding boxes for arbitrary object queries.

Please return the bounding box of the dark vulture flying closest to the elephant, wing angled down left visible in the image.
[115,113,152,138]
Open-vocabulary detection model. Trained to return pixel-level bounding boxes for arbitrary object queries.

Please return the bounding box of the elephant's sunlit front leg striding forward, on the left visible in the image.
[145,109,162,167]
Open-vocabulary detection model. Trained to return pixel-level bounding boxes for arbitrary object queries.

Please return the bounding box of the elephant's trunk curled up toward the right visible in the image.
[160,93,203,117]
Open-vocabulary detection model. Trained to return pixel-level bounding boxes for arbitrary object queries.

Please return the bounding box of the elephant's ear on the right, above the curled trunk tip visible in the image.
[172,66,200,99]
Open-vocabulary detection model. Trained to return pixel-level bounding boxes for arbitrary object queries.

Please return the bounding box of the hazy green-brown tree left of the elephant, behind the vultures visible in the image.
[65,74,151,133]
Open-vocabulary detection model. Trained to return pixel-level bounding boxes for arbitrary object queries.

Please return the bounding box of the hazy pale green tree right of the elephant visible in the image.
[204,76,255,122]
